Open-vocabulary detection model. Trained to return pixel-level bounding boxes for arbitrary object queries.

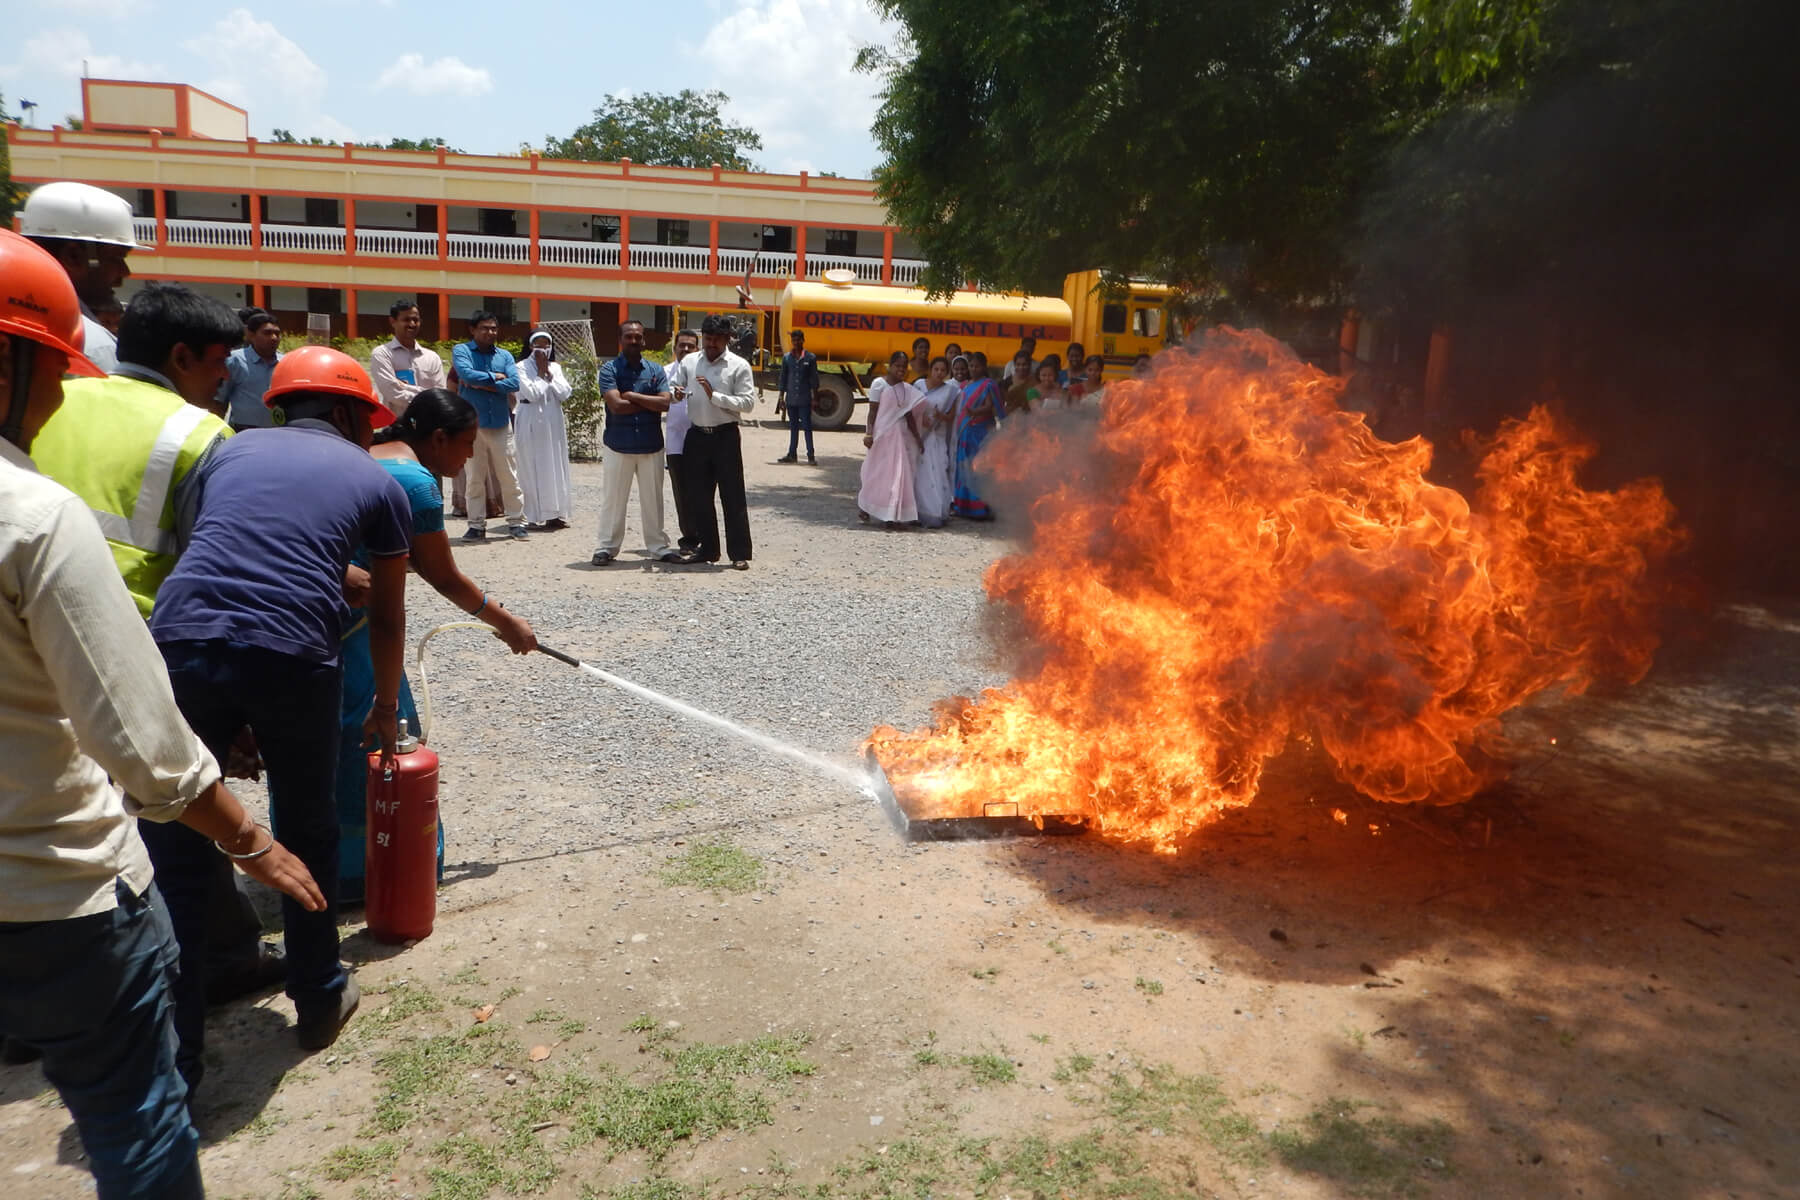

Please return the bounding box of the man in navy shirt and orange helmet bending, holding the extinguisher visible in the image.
[139,345,412,1085]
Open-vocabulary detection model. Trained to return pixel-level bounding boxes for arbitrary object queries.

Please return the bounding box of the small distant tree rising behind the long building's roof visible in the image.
[544,88,763,171]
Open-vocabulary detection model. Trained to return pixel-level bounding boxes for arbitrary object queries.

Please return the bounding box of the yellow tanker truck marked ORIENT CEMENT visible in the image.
[677,272,1174,430]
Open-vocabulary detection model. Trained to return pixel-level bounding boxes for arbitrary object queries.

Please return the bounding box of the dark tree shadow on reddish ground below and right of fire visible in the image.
[1006,606,1800,1196]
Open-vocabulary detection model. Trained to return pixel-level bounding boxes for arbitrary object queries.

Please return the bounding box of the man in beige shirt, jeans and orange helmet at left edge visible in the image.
[0,230,326,1200]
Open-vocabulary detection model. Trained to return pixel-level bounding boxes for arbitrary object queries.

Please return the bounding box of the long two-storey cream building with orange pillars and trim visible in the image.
[7,79,923,349]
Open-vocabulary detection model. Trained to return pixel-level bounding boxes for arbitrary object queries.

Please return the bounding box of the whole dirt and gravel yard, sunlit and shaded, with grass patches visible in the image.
[0,415,1800,1200]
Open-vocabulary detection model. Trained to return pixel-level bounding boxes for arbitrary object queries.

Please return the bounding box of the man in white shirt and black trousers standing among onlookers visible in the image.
[673,313,756,570]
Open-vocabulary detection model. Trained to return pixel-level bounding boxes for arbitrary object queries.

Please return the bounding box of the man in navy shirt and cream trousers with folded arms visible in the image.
[594,320,686,567]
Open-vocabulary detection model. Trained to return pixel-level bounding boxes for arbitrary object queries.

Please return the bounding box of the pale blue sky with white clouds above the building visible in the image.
[0,0,895,176]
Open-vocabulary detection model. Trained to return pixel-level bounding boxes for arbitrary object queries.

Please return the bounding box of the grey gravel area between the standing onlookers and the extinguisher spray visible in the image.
[419,410,1004,864]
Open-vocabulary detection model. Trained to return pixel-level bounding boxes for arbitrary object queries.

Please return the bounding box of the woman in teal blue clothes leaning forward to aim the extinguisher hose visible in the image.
[337,387,538,903]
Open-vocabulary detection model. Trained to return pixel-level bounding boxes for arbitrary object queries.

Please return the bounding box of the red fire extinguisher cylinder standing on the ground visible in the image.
[364,721,437,943]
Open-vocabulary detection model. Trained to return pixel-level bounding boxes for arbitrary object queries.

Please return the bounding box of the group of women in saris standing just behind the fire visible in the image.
[849,333,1150,529]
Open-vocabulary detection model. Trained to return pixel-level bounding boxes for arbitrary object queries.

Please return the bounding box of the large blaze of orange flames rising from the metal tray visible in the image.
[869,331,1679,849]
